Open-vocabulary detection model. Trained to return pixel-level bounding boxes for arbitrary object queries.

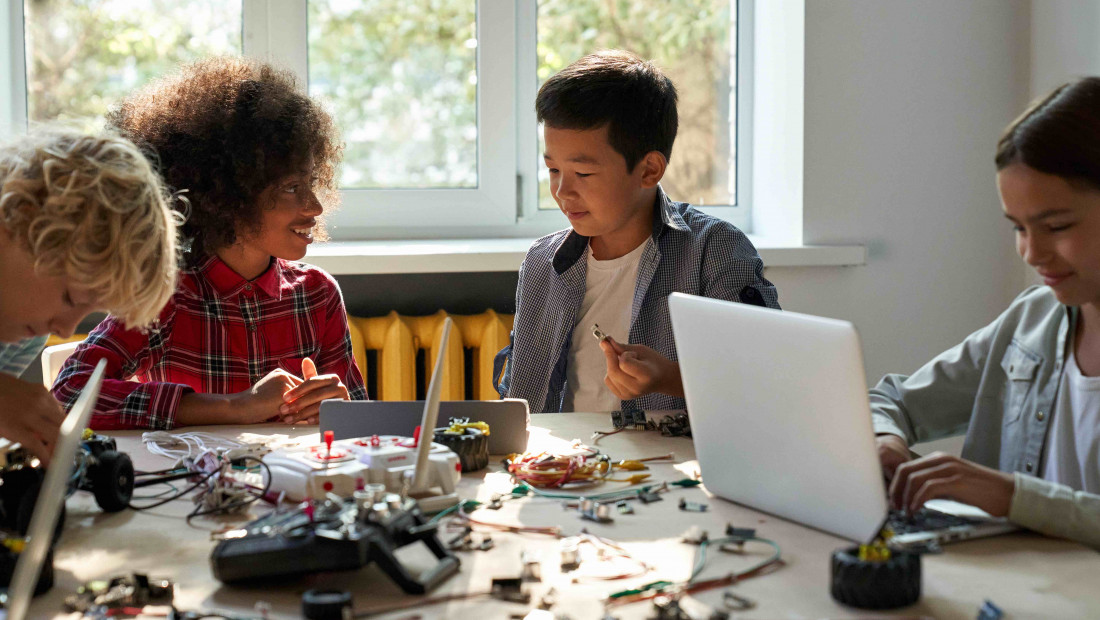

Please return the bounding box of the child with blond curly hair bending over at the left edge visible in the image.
[0,129,178,461]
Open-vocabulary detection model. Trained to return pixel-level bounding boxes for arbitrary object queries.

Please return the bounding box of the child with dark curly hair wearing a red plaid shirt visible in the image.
[53,57,366,429]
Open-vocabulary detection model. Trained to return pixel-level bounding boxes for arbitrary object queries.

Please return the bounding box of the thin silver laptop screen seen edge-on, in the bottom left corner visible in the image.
[0,359,107,620]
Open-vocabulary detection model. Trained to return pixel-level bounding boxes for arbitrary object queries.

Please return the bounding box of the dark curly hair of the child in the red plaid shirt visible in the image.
[107,57,343,256]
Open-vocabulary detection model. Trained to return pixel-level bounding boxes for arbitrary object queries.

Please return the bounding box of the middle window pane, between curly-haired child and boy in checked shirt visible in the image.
[309,0,479,188]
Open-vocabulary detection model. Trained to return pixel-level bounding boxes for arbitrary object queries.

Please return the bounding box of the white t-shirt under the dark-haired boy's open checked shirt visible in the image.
[562,239,649,411]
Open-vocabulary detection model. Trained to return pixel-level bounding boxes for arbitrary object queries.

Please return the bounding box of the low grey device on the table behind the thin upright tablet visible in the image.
[320,398,530,454]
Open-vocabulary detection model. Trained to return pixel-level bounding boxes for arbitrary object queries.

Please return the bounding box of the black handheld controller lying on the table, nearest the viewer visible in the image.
[210,486,459,594]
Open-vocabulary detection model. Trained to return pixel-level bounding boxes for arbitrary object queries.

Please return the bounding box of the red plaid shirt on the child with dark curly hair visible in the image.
[53,256,366,430]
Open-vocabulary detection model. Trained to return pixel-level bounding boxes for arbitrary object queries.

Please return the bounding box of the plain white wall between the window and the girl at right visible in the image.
[757,0,1030,383]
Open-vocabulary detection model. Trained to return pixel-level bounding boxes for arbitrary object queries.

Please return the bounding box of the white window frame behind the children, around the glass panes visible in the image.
[0,0,756,241]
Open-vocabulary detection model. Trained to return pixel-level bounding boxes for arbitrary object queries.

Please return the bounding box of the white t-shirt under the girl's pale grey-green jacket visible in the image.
[1043,345,1100,494]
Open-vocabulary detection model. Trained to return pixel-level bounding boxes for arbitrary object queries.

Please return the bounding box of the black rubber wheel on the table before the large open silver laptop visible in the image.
[832,547,921,609]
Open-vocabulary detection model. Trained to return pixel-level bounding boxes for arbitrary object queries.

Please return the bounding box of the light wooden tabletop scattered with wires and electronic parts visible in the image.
[31,413,1100,620]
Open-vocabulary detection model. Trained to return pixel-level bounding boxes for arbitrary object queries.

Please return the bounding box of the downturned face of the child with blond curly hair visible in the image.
[0,225,98,343]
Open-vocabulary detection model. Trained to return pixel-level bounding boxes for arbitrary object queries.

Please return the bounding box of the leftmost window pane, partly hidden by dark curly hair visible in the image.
[23,0,241,130]
